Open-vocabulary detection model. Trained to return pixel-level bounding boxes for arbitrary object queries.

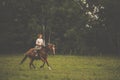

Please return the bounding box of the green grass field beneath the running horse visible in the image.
[0,54,120,80]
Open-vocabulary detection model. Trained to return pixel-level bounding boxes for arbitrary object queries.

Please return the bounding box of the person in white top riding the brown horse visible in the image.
[34,34,44,56]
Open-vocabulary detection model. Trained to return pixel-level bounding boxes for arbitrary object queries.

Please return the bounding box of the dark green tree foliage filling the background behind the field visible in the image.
[0,0,120,54]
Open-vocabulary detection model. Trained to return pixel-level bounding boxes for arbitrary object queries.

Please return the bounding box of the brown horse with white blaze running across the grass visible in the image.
[20,44,55,70]
